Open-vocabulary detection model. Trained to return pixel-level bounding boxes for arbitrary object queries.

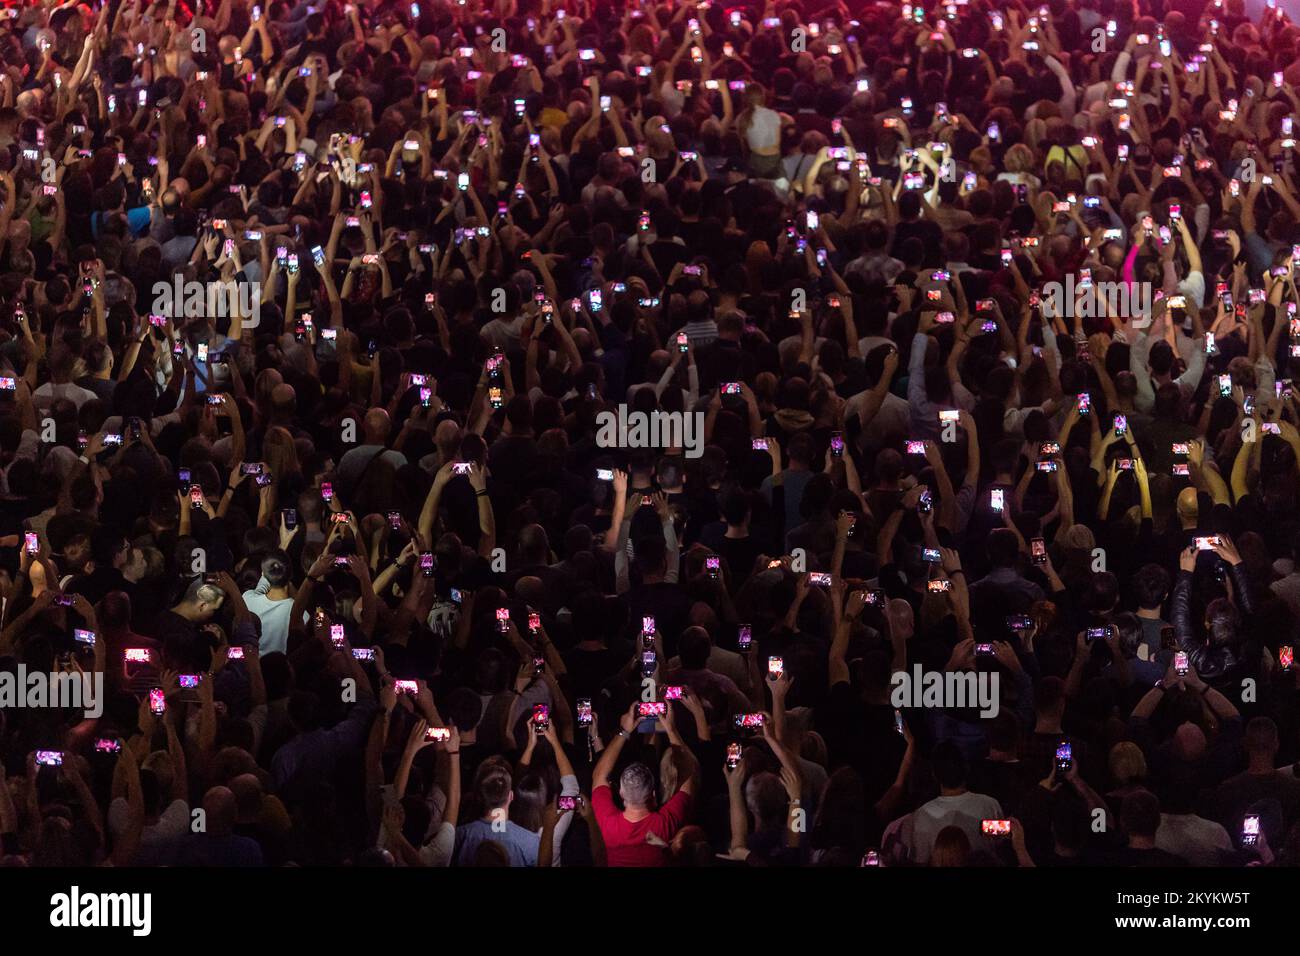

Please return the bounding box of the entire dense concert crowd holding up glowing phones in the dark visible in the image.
[0,0,1300,866]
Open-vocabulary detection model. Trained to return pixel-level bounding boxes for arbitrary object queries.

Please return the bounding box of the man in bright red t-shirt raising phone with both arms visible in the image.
[592,704,699,866]
